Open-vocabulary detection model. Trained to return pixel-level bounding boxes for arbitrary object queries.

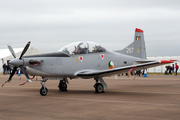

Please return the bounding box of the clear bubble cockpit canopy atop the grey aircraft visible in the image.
[59,41,106,55]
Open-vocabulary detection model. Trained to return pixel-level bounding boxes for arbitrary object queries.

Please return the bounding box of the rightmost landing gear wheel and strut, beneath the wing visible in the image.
[94,78,107,93]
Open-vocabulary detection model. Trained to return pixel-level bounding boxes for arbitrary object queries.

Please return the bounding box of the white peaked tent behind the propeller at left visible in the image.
[0,47,44,73]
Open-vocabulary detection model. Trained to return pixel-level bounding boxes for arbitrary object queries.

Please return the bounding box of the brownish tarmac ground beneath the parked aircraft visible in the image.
[0,75,180,120]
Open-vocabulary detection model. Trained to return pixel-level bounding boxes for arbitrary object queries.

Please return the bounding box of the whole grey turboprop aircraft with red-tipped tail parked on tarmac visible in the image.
[2,28,174,96]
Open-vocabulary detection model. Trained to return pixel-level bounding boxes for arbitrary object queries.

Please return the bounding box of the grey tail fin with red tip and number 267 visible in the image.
[117,28,146,59]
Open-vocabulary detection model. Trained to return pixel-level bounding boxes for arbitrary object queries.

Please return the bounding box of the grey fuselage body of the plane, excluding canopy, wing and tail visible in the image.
[24,51,141,78]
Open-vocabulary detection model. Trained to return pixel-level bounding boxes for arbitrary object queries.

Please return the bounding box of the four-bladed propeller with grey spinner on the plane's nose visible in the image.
[2,41,32,87]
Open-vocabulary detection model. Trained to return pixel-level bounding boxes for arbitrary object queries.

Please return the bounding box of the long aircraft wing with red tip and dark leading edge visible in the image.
[76,60,175,78]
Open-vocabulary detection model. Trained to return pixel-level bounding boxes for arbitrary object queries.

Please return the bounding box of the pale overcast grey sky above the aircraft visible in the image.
[0,0,180,56]
